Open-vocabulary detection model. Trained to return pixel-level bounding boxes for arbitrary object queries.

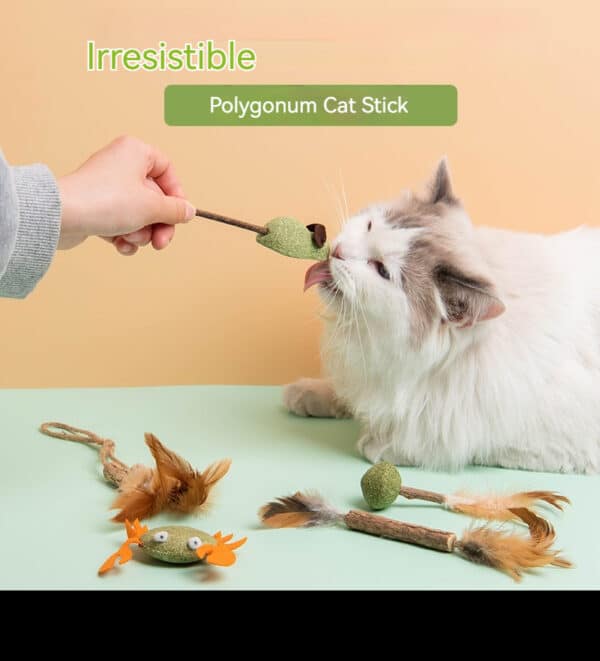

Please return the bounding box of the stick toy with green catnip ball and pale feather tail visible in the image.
[360,461,571,521]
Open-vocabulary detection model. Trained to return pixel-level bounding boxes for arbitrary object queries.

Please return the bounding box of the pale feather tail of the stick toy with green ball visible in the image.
[445,491,571,521]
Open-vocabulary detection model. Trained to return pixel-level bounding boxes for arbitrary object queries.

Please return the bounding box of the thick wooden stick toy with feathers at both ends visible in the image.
[259,491,571,581]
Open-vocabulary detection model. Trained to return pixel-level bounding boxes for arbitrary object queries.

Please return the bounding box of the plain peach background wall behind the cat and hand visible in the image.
[0,0,600,387]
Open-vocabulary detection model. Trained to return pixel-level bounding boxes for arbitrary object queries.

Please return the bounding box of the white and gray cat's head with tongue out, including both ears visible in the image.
[306,161,504,345]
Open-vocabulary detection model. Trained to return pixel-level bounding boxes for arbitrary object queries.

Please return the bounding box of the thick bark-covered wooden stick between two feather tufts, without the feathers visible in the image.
[344,510,456,553]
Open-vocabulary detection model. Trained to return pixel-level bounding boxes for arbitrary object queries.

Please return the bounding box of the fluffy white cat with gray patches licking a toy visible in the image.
[284,161,600,473]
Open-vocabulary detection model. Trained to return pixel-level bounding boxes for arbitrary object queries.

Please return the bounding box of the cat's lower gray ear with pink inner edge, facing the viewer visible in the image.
[435,264,506,328]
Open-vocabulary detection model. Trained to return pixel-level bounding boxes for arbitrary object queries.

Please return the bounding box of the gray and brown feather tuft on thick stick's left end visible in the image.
[258,491,344,528]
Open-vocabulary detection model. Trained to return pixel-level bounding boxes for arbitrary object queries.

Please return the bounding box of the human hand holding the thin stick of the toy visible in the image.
[58,136,195,255]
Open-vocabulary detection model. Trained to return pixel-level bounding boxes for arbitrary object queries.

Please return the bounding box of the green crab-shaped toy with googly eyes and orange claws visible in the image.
[98,519,247,574]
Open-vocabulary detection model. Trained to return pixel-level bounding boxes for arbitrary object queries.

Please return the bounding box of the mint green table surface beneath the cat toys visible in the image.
[0,386,600,590]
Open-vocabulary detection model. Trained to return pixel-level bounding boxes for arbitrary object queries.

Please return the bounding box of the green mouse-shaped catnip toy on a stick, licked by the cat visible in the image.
[196,209,329,262]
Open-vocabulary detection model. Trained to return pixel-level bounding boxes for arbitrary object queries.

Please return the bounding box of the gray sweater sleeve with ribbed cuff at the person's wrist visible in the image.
[0,151,61,298]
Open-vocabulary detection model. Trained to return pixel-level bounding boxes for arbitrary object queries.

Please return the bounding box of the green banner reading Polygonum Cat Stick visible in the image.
[164,85,457,126]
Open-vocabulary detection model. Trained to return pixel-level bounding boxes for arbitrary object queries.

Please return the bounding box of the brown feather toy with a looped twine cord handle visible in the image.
[40,422,231,523]
